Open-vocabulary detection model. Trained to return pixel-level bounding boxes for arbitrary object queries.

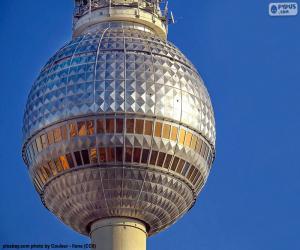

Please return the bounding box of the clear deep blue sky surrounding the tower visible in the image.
[0,0,300,250]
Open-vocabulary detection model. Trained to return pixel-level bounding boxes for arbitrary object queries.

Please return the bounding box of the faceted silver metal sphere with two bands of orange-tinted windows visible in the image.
[23,22,215,235]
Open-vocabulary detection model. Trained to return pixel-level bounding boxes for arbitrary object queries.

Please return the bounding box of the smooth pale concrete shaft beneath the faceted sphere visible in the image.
[90,218,147,250]
